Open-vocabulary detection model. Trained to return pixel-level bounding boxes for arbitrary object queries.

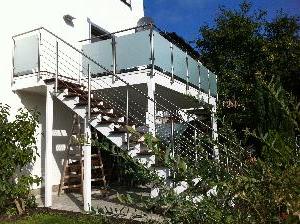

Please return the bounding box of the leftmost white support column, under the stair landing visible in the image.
[45,86,54,207]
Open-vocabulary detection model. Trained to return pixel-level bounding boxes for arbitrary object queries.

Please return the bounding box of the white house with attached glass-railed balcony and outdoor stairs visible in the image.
[0,0,218,210]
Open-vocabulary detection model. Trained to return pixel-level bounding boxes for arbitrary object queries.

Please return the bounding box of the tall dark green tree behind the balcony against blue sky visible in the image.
[197,1,300,140]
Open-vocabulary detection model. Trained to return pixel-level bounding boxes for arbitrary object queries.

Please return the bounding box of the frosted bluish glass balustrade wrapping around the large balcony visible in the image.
[82,29,217,97]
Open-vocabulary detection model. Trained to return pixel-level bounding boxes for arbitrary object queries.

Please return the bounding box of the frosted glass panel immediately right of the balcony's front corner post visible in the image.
[154,32,172,73]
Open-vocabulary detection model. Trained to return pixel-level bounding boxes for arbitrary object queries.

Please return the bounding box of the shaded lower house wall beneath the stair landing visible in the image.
[17,91,73,192]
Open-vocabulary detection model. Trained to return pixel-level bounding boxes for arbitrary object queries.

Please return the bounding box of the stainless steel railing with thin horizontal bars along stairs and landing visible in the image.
[13,28,243,173]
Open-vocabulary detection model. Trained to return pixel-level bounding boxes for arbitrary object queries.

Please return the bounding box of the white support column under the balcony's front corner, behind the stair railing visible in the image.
[146,76,156,136]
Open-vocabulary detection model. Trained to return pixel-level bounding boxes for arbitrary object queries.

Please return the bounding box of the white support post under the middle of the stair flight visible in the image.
[82,118,92,211]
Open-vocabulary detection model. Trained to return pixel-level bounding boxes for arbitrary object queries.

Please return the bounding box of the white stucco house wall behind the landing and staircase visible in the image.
[0,0,144,189]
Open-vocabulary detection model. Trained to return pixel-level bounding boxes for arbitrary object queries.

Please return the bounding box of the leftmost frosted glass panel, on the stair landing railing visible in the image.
[14,35,39,76]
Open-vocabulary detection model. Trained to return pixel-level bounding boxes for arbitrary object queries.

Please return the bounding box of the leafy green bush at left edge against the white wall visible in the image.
[0,104,41,213]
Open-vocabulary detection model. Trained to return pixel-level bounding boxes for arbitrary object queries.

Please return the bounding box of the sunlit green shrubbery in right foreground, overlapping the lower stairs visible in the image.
[139,76,300,223]
